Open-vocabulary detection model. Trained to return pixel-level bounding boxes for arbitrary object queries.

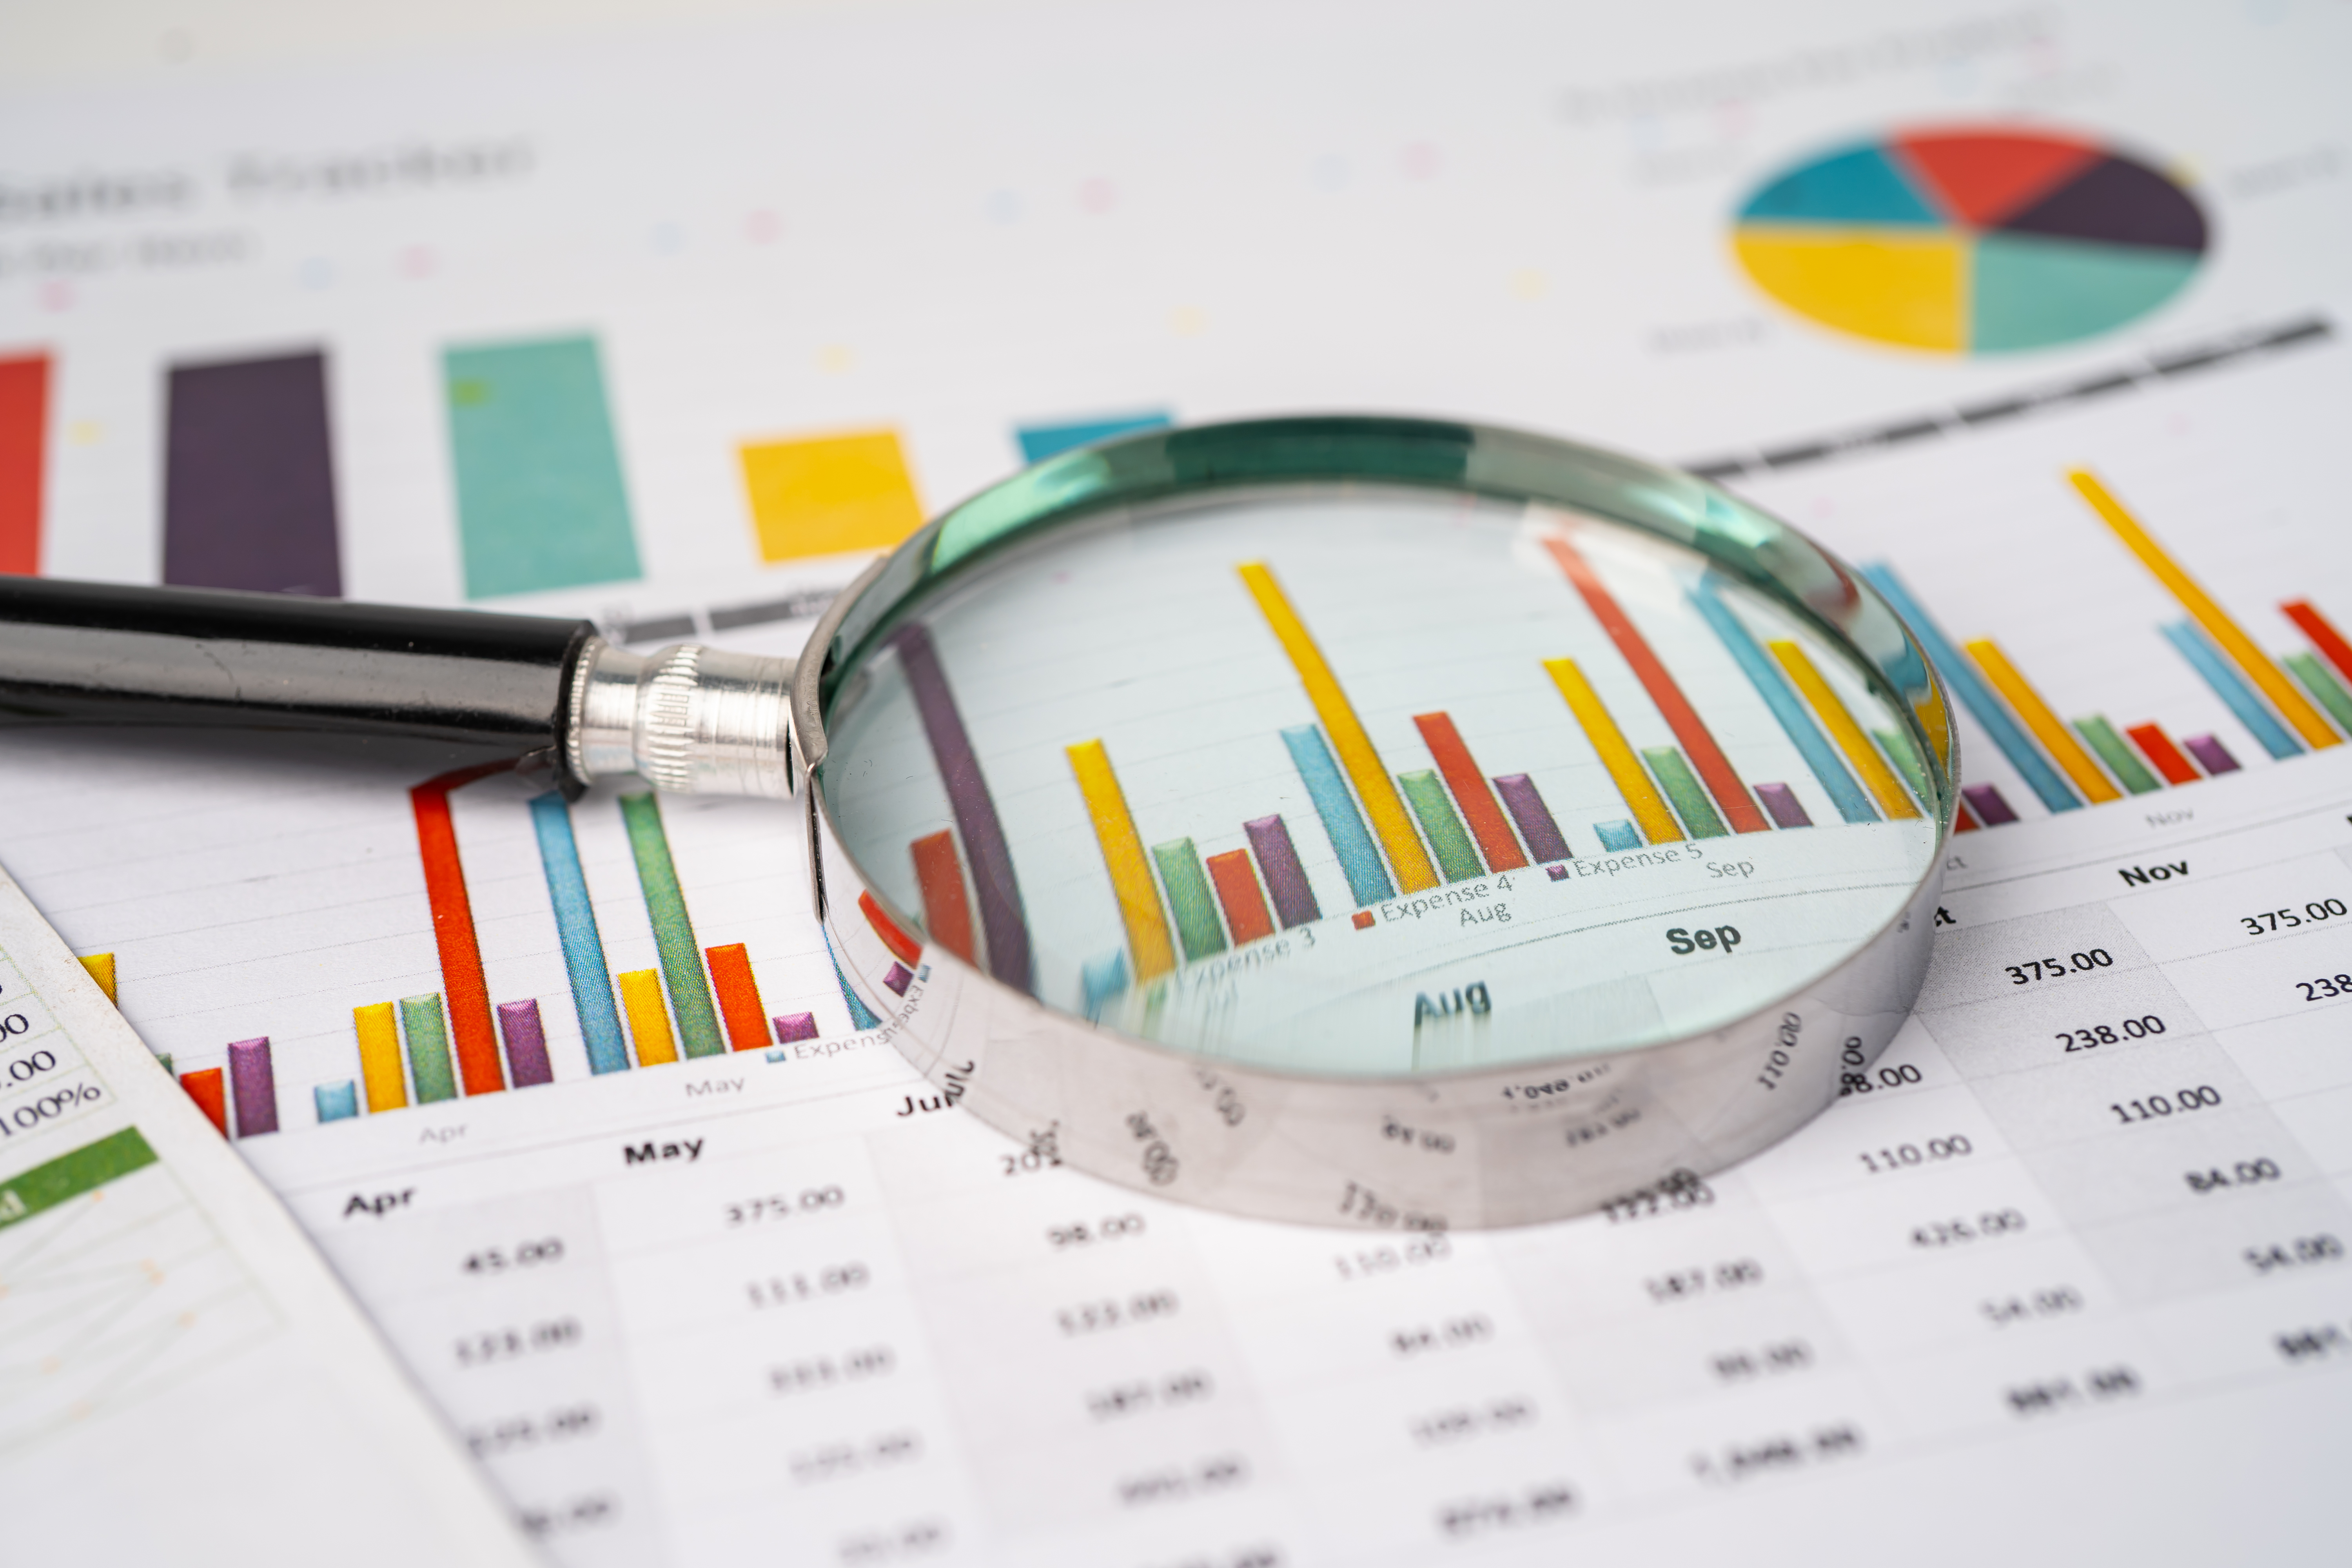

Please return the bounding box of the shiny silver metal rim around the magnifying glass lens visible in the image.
[790,416,1957,1229]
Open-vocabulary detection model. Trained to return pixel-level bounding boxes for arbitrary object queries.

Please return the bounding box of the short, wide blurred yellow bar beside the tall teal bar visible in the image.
[743,430,922,562]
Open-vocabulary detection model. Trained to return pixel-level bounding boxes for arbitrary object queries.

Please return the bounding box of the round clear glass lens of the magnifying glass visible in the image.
[816,484,1938,1079]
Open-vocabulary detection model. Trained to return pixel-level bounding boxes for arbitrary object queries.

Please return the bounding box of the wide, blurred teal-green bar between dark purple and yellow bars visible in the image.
[442,339,644,599]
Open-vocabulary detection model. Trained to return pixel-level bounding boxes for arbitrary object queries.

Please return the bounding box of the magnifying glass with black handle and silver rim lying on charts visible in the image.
[0,418,1955,1229]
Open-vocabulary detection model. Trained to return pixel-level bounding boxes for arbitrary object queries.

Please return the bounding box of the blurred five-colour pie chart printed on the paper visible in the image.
[1733,127,2209,355]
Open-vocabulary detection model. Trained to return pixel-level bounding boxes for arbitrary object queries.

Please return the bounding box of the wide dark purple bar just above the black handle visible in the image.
[162,353,343,599]
